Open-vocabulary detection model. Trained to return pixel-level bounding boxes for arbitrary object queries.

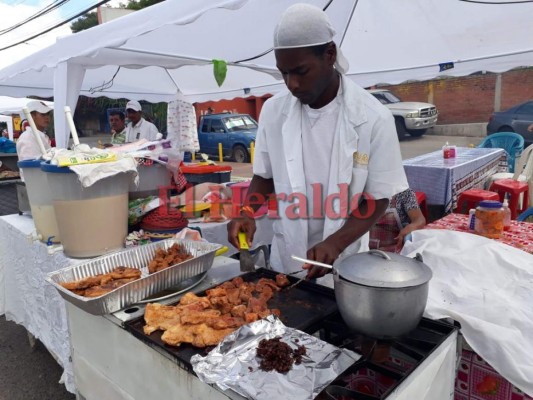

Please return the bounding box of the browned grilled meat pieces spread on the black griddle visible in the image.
[144,274,289,347]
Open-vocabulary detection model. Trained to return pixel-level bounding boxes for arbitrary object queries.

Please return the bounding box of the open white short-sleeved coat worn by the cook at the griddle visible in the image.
[253,77,408,272]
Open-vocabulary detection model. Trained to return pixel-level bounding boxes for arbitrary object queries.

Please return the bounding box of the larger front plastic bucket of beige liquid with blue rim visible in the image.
[41,163,131,258]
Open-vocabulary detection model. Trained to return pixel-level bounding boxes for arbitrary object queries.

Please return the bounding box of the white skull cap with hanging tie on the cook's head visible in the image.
[274,3,350,74]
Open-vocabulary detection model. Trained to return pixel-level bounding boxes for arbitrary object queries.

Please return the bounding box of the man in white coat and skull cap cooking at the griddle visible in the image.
[228,4,408,278]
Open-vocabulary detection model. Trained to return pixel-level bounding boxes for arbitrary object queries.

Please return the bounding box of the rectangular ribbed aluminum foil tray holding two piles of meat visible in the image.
[46,239,222,315]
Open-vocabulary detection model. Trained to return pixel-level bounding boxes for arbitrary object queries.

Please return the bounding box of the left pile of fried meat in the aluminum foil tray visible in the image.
[59,267,141,297]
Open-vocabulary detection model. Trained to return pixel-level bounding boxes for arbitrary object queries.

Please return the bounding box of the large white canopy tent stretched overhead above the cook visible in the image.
[0,0,533,146]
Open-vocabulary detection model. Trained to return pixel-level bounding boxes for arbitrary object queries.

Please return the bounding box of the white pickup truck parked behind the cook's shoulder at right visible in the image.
[369,89,439,139]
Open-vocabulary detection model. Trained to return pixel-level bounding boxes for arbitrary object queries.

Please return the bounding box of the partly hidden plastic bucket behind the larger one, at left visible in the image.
[17,160,61,243]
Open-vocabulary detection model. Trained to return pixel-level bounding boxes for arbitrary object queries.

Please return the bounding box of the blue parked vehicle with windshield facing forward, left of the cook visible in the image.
[198,113,257,163]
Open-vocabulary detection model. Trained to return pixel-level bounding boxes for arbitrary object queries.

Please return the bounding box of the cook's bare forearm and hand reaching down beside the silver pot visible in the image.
[303,199,389,279]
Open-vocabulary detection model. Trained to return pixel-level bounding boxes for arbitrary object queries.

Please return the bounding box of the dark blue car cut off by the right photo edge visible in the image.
[487,100,533,143]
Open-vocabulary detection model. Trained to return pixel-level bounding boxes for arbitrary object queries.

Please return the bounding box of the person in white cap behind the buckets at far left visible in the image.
[17,100,52,161]
